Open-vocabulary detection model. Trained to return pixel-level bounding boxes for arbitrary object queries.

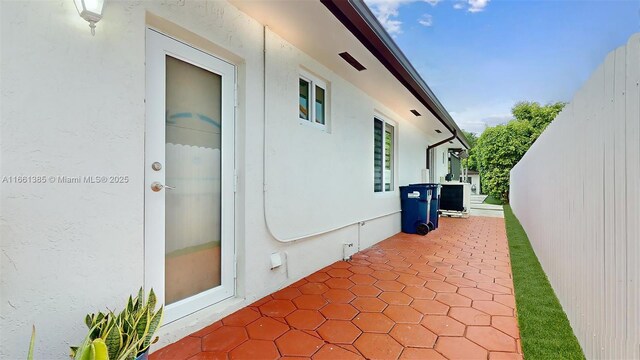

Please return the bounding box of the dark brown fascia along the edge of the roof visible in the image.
[320,0,469,149]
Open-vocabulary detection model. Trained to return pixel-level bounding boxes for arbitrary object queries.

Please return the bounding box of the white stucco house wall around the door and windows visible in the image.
[0,0,446,358]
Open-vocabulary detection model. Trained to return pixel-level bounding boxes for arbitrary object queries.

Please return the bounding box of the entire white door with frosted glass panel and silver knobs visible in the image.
[145,29,235,323]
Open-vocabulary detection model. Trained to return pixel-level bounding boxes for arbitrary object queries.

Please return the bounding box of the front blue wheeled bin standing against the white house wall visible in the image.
[400,185,431,235]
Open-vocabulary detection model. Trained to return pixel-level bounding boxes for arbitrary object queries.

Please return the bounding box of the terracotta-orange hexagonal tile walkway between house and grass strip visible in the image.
[151,217,522,360]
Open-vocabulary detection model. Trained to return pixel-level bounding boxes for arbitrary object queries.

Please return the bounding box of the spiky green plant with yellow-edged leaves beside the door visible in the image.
[71,288,163,360]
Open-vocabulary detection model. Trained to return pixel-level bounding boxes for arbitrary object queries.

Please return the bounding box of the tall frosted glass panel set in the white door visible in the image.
[165,56,222,304]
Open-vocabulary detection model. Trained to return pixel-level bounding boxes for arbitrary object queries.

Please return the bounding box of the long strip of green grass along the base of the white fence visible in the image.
[504,205,585,360]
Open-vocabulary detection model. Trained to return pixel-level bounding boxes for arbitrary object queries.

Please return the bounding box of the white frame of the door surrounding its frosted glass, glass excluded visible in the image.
[144,28,237,324]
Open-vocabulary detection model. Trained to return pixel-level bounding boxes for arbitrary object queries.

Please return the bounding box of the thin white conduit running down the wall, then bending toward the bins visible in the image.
[262,25,400,245]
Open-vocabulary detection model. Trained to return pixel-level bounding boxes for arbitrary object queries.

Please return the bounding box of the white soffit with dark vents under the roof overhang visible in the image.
[231,0,444,141]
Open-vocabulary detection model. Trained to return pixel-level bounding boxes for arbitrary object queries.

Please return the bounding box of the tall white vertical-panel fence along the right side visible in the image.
[510,34,640,359]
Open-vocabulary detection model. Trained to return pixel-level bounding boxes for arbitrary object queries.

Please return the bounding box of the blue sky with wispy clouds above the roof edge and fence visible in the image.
[366,0,640,134]
